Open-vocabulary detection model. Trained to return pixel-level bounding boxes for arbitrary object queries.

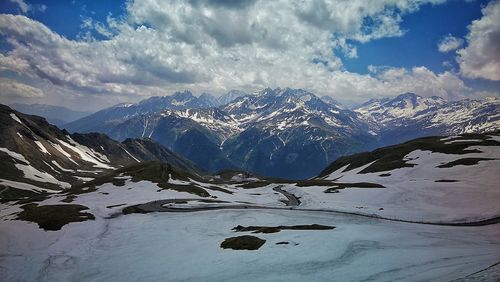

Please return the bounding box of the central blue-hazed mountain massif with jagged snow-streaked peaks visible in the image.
[79,88,376,178]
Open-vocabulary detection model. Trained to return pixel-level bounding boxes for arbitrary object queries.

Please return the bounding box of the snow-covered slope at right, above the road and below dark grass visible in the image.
[292,140,500,222]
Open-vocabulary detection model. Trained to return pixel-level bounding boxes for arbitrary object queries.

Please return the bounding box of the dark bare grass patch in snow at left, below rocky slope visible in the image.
[17,203,95,231]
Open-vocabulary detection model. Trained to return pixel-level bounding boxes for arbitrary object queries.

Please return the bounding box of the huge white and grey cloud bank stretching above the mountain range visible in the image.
[0,0,468,108]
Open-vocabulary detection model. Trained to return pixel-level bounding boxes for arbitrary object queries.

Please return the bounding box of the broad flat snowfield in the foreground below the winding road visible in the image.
[0,211,500,281]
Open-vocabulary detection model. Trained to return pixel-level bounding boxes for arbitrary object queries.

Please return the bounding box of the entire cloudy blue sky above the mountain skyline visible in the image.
[0,0,500,110]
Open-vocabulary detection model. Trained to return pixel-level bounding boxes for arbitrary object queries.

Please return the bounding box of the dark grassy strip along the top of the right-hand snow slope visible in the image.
[319,134,500,177]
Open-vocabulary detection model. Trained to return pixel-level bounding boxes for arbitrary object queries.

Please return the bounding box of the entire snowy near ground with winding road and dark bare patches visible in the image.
[0,127,500,280]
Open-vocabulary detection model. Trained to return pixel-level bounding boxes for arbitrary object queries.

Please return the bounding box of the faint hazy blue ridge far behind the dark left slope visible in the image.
[10,103,91,126]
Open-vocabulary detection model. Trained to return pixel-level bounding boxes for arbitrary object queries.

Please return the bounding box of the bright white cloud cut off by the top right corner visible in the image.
[457,1,500,81]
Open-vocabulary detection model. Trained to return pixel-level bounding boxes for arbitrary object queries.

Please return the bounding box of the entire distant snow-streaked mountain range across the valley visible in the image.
[64,88,500,179]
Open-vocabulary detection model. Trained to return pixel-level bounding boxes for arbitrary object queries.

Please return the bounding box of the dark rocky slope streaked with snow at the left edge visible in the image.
[0,105,203,192]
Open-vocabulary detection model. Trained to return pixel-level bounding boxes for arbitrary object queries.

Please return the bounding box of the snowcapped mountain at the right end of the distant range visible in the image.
[354,93,500,144]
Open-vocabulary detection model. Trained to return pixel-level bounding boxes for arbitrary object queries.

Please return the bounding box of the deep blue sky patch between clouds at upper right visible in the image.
[344,0,488,73]
